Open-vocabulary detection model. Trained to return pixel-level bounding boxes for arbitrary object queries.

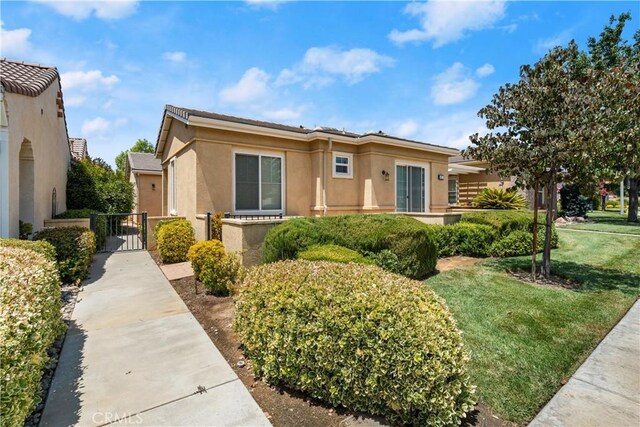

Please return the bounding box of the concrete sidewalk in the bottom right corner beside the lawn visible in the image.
[529,301,640,427]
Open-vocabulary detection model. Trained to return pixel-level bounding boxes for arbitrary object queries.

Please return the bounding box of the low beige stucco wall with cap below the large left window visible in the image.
[222,218,286,267]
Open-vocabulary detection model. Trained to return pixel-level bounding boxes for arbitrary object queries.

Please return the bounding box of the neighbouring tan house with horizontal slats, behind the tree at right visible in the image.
[449,155,545,209]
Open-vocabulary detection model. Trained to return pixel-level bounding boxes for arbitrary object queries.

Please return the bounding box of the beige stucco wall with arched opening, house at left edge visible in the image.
[5,81,70,237]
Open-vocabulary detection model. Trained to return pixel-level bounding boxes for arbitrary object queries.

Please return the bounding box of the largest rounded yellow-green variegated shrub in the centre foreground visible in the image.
[234,260,474,425]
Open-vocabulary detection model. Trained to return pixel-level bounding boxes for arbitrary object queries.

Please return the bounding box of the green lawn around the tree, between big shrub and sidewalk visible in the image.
[426,227,640,424]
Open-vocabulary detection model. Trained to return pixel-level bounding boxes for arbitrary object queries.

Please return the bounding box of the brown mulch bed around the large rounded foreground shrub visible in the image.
[161,251,514,427]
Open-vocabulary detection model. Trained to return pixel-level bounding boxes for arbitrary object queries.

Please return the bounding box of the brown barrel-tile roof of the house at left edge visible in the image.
[0,59,59,96]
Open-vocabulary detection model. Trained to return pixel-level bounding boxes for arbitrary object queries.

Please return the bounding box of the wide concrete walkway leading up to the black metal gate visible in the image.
[40,251,270,426]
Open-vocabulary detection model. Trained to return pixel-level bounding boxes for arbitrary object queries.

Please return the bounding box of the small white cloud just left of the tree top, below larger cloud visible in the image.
[431,62,480,105]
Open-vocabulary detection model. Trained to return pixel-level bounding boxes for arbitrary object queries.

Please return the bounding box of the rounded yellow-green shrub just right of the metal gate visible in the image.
[156,219,196,264]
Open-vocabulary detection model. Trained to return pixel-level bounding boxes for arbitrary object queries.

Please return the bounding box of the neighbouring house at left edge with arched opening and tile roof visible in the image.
[0,59,70,237]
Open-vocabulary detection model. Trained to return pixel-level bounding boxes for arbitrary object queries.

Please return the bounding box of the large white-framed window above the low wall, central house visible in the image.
[234,153,283,212]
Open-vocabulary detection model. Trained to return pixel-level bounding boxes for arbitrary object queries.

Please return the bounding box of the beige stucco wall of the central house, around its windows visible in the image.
[162,120,456,238]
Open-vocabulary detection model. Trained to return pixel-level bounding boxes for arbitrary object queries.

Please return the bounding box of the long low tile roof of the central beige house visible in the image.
[165,105,458,149]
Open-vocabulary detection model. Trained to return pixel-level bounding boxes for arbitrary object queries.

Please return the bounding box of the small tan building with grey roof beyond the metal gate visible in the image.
[125,151,162,216]
